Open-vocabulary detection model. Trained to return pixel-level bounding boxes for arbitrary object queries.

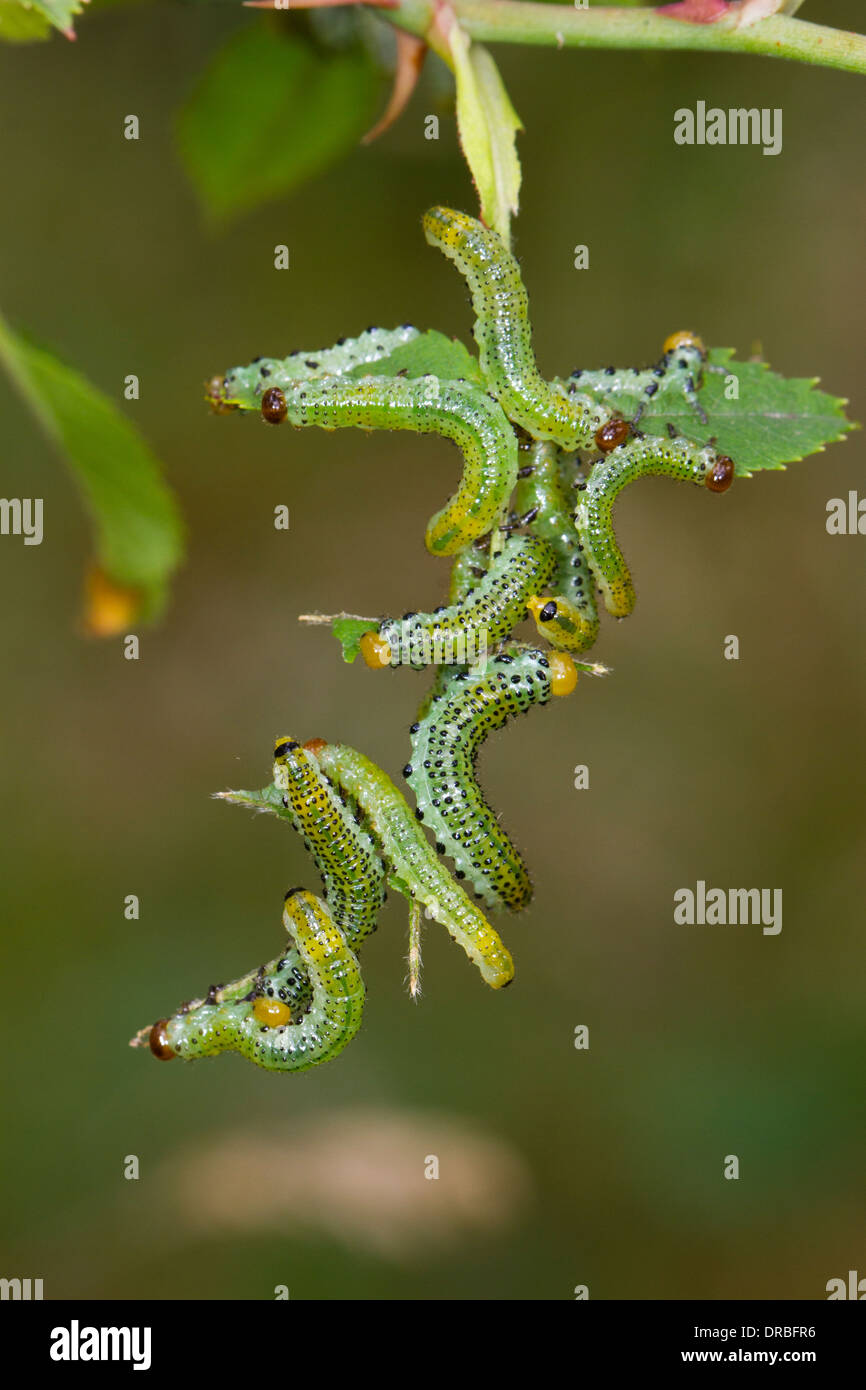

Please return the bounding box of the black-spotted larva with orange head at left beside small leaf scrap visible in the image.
[360,533,556,670]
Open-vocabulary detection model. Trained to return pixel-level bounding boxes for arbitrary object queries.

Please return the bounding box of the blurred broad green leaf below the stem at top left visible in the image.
[178,24,381,222]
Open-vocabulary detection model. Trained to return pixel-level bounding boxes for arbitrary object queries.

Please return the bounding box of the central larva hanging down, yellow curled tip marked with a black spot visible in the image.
[514,441,599,652]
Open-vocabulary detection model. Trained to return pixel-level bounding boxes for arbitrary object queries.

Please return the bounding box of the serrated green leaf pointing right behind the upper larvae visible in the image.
[567,348,856,477]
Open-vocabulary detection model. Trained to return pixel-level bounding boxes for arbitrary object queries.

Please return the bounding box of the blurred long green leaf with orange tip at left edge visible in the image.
[0,318,183,634]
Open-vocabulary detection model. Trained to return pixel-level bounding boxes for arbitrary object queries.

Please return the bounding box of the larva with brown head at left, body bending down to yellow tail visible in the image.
[211,368,517,555]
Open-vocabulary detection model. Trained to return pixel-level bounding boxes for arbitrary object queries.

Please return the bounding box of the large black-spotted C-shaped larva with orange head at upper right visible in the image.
[403,648,577,912]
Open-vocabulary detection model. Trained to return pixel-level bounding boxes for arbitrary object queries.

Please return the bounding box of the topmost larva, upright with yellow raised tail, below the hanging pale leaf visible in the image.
[424,207,609,449]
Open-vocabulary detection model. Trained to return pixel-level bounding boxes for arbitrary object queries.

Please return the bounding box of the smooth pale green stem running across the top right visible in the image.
[377,0,866,72]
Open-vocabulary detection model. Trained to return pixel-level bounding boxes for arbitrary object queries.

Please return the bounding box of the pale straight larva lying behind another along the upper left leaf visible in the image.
[209,324,418,411]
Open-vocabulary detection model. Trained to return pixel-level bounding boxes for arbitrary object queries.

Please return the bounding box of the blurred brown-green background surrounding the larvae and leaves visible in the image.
[0,0,866,1300]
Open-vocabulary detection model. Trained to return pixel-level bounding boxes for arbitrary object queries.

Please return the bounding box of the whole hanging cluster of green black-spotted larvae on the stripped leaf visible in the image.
[132,207,734,1070]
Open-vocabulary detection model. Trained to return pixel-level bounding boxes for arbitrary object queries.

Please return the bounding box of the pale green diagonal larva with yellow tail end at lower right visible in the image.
[306,739,514,990]
